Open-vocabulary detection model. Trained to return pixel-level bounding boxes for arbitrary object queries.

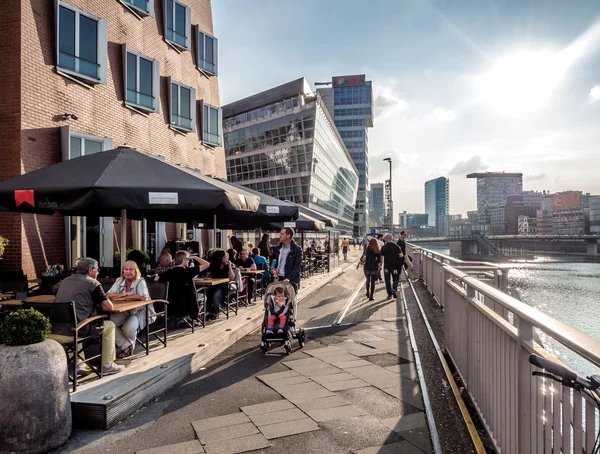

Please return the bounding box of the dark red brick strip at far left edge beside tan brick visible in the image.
[0,2,21,269]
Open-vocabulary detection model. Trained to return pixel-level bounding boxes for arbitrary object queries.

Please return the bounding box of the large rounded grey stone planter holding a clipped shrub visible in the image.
[0,339,72,454]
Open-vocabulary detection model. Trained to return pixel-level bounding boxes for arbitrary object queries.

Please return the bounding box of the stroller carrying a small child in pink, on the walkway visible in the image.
[260,282,306,355]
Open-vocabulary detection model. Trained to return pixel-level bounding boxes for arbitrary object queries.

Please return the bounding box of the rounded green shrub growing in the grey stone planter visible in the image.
[0,308,51,346]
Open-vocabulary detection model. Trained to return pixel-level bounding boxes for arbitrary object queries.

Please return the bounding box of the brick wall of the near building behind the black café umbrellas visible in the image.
[0,0,226,275]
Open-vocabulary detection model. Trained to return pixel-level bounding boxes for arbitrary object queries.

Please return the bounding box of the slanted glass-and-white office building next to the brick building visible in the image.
[223,77,358,234]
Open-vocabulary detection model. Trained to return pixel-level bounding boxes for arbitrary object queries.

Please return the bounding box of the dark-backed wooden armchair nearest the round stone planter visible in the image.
[23,301,106,392]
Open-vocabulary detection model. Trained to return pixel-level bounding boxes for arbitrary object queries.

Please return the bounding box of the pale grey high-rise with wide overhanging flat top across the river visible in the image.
[467,172,523,224]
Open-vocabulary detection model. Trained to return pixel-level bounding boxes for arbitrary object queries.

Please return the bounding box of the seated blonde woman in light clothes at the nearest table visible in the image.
[106,260,156,358]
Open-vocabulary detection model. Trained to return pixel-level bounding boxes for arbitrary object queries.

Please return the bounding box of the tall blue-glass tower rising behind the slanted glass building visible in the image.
[317,74,373,236]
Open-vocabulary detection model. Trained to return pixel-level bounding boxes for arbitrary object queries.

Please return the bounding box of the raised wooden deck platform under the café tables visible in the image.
[71,264,349,430]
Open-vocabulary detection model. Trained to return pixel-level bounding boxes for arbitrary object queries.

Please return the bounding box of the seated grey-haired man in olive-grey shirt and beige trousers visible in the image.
[55,257,125,375]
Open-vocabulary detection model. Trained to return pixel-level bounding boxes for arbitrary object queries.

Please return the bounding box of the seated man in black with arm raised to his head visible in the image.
[154,251,209,322]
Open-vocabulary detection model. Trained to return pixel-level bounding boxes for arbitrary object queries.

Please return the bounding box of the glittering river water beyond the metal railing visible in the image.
[427,247,600,375]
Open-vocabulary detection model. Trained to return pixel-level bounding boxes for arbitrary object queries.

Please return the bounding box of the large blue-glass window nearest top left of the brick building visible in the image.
[56,0,108,84]
